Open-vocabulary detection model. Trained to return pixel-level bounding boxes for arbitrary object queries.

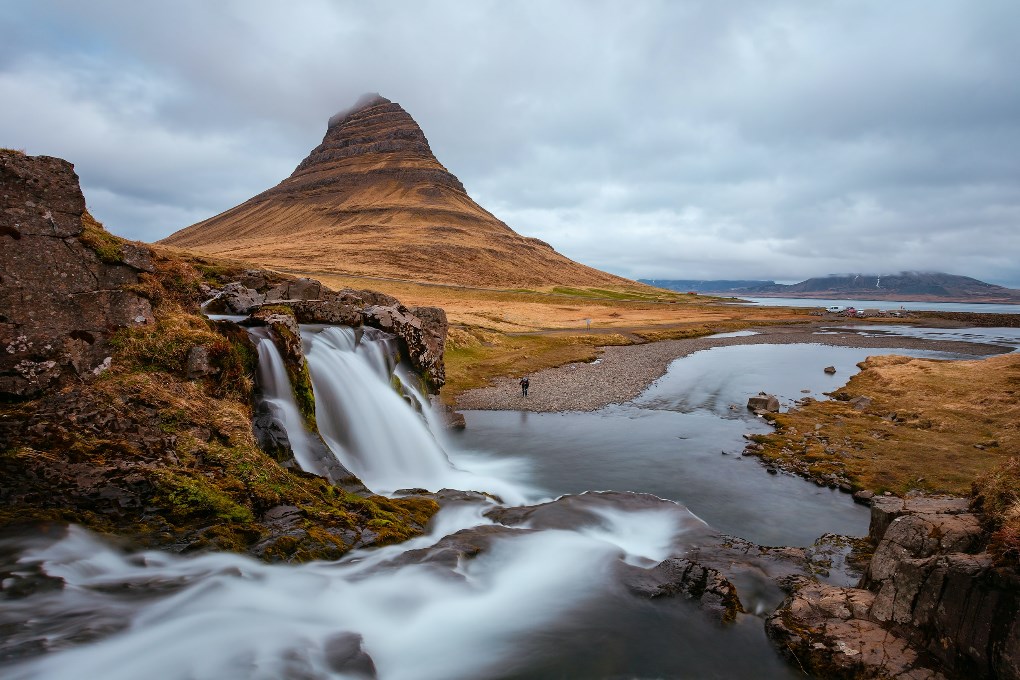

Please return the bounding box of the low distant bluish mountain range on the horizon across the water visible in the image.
[641,271,1020,304]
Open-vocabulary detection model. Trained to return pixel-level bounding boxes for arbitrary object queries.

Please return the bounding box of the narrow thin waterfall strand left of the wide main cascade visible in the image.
[250,328,325,475]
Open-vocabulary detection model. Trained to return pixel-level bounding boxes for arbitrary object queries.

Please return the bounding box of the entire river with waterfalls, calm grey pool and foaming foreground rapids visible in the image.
[0,326,987,680]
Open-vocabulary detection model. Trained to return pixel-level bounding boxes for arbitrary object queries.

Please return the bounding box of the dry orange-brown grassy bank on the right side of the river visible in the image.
[762,354,1020,494]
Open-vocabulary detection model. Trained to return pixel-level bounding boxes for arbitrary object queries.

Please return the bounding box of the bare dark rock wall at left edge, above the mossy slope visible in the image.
[0,152,153,400]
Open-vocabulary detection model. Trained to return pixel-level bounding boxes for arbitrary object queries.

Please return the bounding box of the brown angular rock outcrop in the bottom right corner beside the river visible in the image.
[767,496,1020,680]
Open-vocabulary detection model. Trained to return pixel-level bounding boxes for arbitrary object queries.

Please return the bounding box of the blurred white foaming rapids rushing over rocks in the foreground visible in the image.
[0,499,734,680]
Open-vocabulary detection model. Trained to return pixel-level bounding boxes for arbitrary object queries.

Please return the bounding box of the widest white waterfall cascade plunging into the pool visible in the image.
[301,326,537,504]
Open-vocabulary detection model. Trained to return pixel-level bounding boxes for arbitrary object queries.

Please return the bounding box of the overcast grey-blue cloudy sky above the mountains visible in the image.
[0,0,1020,287]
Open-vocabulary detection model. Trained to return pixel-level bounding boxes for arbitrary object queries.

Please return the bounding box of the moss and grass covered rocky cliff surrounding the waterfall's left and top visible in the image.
[0,152,445,562]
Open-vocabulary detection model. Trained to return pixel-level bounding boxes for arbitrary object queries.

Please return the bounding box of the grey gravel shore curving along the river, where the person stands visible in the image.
[456,321,1009,413]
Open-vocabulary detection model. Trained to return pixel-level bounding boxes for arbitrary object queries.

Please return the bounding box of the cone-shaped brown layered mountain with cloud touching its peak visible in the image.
[161,94,634,287]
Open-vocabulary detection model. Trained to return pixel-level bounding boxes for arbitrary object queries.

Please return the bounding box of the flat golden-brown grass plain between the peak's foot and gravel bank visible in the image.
[299,270,813,404]
